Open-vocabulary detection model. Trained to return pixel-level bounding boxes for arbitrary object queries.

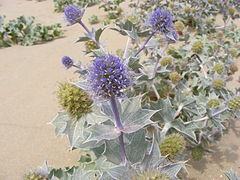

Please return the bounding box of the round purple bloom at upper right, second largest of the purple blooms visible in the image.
[148,8,174,33]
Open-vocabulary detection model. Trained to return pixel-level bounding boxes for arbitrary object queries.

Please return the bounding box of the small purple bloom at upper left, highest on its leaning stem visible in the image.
[64,5,85,25]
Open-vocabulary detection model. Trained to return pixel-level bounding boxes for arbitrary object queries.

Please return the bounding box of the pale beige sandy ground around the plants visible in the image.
[0,0,240,180]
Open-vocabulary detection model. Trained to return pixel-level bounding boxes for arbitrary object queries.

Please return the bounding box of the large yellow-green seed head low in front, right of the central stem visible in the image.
[159,134,186,160]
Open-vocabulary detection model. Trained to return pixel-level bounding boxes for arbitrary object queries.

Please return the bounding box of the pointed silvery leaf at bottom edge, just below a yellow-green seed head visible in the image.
[159,162,186,179]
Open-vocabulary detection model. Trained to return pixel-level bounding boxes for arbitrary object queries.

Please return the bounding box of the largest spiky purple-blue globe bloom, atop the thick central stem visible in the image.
[88,55,131,99]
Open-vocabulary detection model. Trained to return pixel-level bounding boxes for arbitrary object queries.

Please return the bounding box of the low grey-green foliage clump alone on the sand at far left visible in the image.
[0,16,62,48]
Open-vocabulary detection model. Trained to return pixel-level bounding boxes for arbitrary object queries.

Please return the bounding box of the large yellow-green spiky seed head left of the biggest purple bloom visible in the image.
[57,82,93,119]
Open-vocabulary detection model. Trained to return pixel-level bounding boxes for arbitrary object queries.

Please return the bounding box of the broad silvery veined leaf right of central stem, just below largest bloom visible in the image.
[121,96,157,134]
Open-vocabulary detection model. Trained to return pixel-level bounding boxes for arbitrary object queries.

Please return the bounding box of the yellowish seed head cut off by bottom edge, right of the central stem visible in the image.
[131,169,170,180]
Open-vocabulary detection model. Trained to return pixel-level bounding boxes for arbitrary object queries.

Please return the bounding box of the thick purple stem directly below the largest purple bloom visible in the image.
[110,96,127,162]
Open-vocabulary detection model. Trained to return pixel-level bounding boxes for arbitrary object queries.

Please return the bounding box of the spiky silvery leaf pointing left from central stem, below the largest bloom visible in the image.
[84,124,121,143]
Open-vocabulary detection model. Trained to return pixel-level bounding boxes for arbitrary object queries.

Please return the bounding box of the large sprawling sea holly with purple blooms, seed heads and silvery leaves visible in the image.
[28,1,240,180]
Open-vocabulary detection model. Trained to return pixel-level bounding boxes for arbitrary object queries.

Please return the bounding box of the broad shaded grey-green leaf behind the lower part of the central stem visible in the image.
[104,130,148,164]
